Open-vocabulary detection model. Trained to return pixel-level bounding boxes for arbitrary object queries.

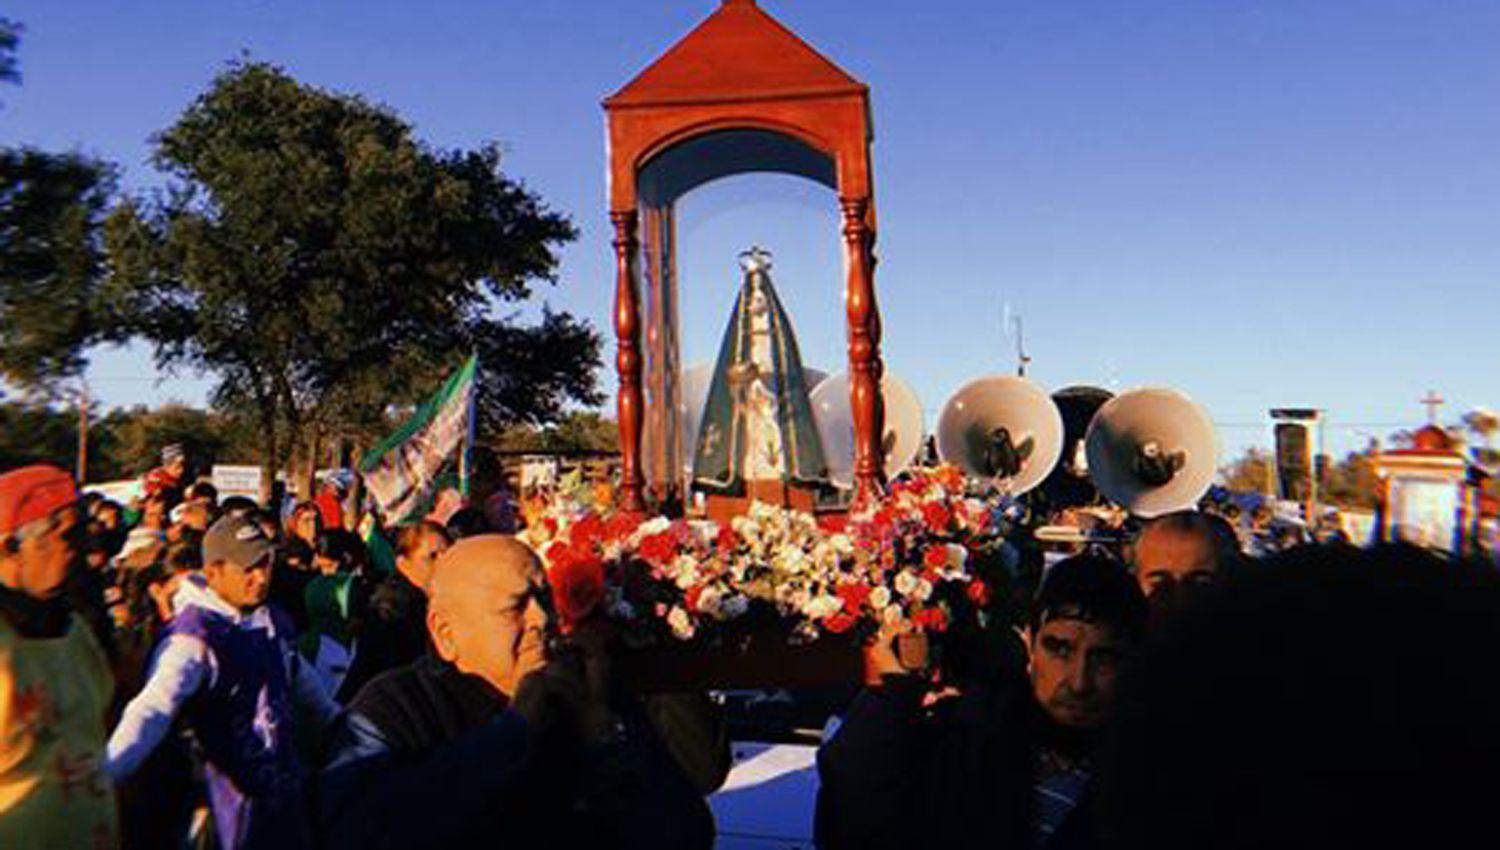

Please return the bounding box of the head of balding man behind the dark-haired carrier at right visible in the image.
[1131,511,1238,609]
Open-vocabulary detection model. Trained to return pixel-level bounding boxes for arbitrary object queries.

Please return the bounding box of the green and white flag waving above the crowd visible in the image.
[360,357,477,525]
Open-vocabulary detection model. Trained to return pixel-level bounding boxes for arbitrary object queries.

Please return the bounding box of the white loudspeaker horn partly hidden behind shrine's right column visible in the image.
[810,372,923,490]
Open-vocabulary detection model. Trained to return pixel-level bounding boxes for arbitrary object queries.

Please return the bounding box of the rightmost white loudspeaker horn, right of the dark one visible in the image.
[1085,387,1218,519]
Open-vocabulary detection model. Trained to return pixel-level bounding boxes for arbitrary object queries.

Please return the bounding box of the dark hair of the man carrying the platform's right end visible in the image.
[1031,553,1148,643]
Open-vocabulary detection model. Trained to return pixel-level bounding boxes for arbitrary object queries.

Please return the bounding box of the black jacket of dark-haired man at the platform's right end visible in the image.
[815,672,1097,850]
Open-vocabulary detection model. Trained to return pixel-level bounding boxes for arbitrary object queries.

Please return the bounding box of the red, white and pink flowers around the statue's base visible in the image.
[521,466,1007,645]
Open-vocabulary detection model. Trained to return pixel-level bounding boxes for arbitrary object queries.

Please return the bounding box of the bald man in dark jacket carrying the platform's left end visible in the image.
[320,535,714,850]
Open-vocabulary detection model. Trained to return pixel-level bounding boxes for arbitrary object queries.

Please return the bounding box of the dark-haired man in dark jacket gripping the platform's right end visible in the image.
[815,556,1146,850]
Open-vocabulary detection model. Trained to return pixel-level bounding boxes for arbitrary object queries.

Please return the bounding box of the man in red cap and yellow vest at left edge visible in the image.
[0,465,119,847]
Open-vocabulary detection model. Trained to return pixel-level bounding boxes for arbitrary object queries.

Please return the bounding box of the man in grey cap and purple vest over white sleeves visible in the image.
[105,516,338,850]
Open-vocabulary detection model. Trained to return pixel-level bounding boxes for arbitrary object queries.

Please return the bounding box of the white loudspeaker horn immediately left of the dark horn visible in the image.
[938,375,1064,496]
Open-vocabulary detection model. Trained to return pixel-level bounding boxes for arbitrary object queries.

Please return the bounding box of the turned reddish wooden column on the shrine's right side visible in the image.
[839,198,885,502]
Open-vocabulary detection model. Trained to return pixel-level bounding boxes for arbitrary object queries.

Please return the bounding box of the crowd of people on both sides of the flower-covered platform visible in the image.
[0,448,1500,850]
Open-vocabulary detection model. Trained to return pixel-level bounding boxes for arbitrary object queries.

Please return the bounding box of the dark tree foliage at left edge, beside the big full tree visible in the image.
[0,148,117,393]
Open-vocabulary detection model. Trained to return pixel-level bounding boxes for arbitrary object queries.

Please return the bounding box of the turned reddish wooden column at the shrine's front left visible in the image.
[609,210,645,511]
